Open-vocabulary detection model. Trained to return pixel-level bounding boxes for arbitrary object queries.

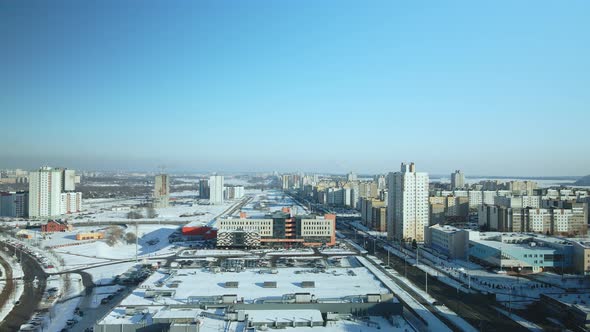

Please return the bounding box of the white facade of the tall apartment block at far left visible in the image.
[29,167,63,218]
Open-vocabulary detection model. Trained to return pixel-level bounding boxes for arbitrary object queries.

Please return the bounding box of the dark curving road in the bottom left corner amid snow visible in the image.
[0,242,47,331]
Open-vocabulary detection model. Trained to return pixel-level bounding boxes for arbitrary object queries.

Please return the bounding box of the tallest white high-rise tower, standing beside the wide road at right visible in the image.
[387,163,428,242]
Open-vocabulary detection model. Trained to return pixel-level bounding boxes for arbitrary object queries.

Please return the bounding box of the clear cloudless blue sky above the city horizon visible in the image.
[0,0,590,175]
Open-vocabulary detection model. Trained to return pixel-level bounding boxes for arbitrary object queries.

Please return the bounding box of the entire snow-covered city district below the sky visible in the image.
[0,163,590,332]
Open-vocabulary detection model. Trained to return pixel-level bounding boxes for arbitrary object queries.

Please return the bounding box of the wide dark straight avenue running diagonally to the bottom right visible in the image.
[338,228,526,331]
